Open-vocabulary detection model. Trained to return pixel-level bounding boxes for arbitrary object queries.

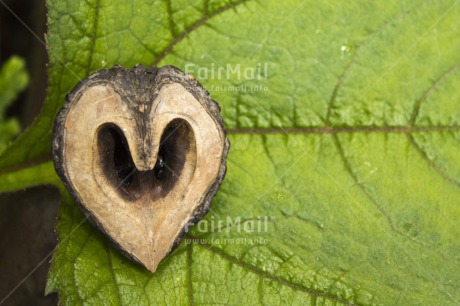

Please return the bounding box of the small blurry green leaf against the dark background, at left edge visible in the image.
[0,56,29,153]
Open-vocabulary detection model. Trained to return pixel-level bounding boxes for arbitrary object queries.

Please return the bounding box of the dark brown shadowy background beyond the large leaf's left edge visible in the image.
[0,0,59,305]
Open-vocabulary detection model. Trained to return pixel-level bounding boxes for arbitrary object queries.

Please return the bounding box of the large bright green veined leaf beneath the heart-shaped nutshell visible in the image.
[0,0,460,305]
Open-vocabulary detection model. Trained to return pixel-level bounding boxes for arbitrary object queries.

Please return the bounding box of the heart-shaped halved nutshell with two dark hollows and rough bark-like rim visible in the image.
[53,65,229,272]
